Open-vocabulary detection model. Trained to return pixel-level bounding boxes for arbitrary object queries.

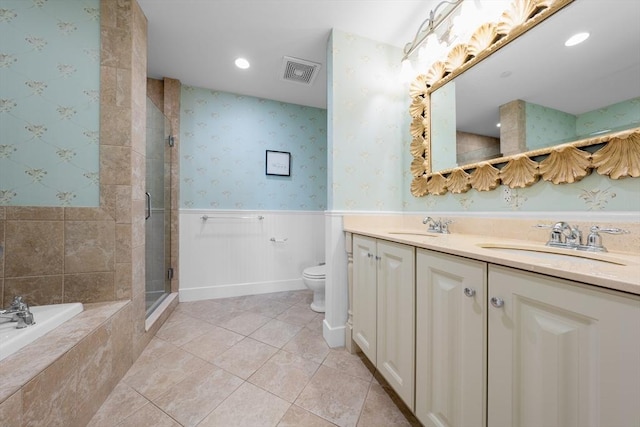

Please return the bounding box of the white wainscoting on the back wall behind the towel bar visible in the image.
[179,209,325,301]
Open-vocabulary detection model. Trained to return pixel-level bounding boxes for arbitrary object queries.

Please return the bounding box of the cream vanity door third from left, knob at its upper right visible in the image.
[415,249,484,427]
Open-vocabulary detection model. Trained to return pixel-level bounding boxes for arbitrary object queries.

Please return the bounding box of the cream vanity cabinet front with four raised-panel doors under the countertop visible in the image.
[350,234,640,427]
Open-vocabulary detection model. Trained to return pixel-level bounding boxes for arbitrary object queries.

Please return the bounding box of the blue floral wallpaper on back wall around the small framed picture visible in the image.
[180,85,327,210]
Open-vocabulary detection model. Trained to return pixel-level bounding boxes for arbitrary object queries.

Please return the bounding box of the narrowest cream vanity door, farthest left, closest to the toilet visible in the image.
[352,235,378,365]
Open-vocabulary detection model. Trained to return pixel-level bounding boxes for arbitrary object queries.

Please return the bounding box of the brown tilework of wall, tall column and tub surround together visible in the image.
[0,0,180,425]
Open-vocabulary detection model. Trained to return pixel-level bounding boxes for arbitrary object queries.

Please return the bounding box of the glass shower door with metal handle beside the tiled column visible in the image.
[145,98,173,316]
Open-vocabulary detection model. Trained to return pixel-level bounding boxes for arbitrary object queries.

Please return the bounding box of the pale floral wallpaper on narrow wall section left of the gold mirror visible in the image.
[327,29,410,211]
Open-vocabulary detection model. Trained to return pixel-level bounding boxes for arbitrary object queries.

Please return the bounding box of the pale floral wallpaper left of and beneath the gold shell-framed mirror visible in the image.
[328,30,640,212]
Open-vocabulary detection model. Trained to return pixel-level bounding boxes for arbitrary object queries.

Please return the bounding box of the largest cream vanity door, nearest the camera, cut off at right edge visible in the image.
[487,266,640,427]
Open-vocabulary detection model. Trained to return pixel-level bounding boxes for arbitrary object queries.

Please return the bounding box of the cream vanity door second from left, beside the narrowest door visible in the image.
[376,241,415,410]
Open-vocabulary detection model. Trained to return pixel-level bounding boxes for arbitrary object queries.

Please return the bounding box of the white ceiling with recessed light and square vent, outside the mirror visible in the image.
[138,0,437,108]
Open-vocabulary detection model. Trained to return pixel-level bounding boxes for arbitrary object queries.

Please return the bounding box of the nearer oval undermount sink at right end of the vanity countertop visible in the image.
[477,243,628,265]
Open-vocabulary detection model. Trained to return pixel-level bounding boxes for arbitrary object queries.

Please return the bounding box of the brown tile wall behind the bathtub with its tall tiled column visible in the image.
[0,0,175,359]
